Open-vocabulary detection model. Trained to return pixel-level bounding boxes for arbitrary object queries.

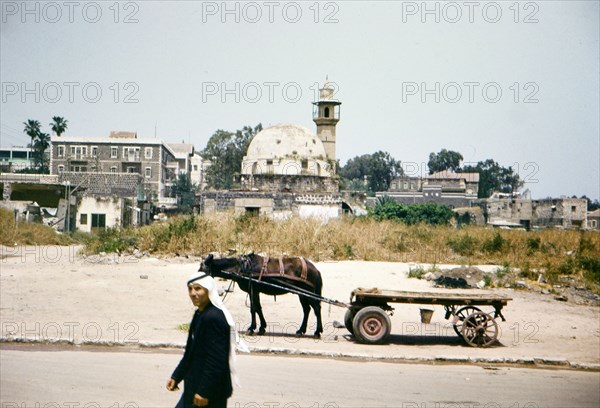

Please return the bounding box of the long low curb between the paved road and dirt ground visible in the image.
[0,337,600,372]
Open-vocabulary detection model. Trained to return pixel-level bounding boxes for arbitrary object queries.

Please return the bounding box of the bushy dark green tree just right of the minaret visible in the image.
[339,151,403,193]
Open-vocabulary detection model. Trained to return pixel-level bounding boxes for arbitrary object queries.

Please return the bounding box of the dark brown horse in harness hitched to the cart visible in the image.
[200,253,323,338]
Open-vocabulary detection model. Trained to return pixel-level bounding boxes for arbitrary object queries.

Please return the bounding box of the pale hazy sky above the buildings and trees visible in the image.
[0,0,600,198]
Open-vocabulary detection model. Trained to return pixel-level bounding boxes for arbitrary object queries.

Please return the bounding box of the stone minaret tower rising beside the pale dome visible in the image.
[313,80,342,165]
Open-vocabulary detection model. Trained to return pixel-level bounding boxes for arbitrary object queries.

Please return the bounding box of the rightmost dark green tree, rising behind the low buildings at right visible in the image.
[461,159,524,198]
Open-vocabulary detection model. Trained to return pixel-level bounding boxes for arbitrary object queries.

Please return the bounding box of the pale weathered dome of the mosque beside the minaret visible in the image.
[245,124,327,160]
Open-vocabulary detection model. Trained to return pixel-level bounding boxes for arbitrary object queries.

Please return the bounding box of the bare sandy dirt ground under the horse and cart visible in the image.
[0,246,600,369]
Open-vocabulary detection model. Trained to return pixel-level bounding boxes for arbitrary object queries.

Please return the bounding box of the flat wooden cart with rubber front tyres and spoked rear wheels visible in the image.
[344,288,512,347]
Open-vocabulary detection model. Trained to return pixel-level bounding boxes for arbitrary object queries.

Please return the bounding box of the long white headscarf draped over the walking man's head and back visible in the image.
[187,272,250,387]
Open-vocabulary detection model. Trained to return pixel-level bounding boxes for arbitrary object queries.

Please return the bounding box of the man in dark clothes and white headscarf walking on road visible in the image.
[167,272,235,408]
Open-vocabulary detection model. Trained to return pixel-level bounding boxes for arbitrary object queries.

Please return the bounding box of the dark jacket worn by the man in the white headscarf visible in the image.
[171,303,232,405]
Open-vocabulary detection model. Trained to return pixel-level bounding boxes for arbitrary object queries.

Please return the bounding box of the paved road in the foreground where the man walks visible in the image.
[0,344,600,408]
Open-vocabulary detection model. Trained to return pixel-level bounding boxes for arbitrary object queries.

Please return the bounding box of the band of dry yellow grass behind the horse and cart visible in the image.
[0,210,600,292]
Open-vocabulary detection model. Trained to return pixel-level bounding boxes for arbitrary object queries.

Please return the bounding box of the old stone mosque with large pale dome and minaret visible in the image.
[197,83,343,219]
